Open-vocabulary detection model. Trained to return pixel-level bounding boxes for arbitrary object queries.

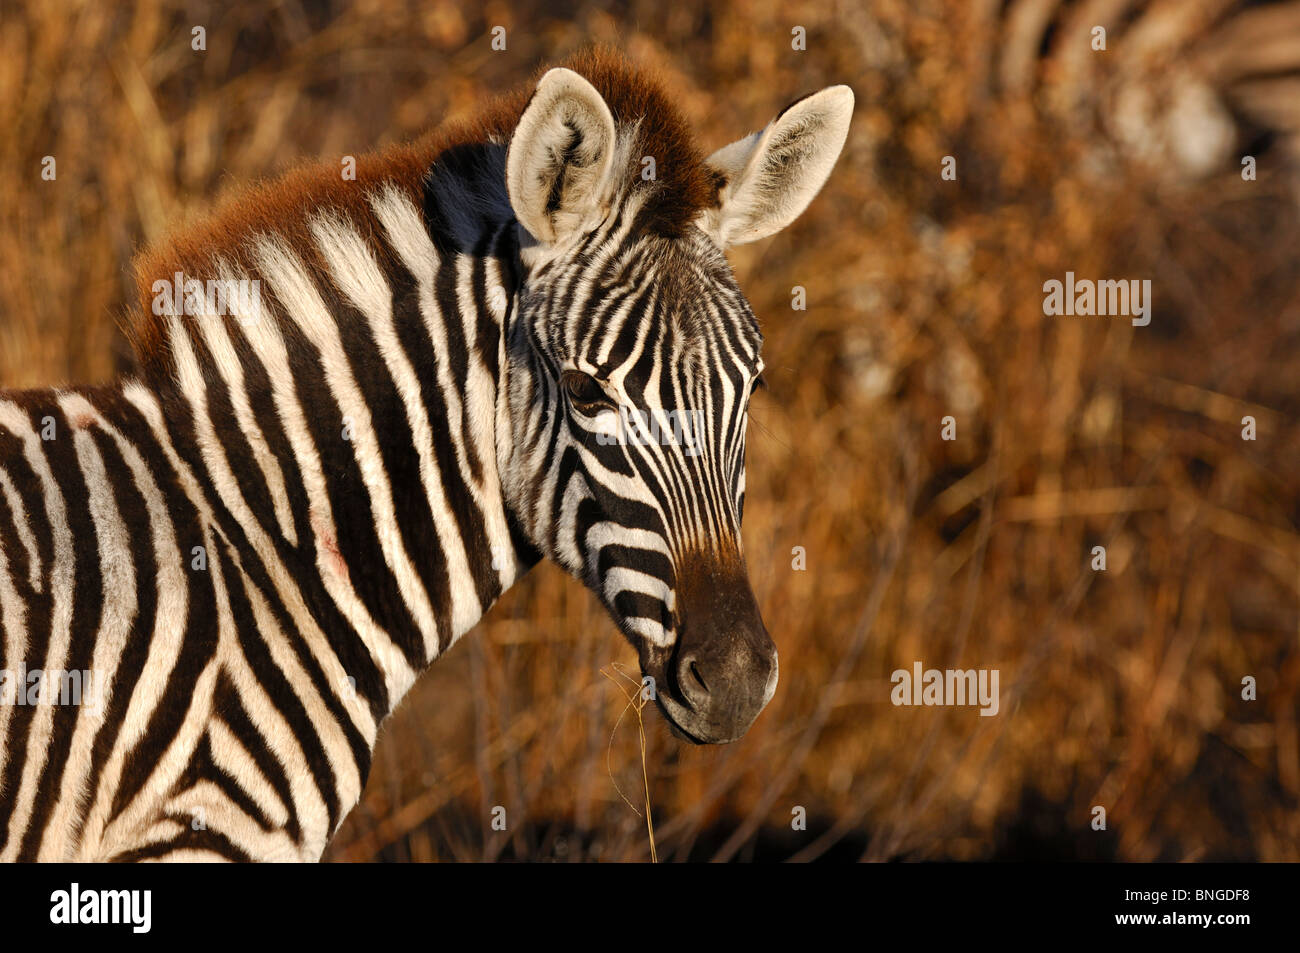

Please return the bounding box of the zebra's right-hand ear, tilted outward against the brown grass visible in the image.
[701,86,853,248]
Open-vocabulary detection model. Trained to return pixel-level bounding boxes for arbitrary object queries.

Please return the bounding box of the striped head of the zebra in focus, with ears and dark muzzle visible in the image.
[498,69,853,742]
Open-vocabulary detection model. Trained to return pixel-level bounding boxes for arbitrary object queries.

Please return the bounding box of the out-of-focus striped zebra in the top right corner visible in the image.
[965,0,1300,182]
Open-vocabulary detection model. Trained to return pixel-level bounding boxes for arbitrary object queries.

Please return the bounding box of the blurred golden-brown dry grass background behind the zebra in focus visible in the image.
[0,0,1300,861]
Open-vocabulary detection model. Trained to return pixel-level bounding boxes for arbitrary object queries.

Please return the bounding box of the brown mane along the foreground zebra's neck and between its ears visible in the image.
[124,47,723,380]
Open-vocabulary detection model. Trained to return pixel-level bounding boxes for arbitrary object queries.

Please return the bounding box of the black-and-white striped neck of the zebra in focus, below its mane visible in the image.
[143,190,538,714]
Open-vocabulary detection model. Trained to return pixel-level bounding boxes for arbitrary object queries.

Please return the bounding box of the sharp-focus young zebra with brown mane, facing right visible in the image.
[0,49,854,861]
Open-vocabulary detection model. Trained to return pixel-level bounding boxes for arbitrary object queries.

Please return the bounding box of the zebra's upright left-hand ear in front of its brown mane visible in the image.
[506,69,615,244]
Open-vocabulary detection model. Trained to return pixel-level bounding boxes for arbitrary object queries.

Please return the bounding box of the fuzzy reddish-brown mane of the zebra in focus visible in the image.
[126,48,719,371]
